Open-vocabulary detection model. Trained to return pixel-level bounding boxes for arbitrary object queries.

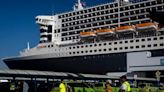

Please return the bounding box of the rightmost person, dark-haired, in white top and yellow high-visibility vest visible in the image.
[120,75,131,92]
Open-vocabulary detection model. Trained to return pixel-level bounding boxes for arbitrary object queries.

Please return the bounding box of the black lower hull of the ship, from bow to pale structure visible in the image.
[4,53,127,74]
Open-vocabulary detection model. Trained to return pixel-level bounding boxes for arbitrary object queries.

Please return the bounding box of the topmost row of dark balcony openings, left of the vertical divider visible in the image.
[59,3,118,18]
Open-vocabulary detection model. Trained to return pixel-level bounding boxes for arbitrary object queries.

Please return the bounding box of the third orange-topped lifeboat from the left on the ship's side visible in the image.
[116,26,135,33]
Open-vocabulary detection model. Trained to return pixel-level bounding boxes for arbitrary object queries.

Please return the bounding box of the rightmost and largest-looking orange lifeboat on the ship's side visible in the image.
[136,22,157,31]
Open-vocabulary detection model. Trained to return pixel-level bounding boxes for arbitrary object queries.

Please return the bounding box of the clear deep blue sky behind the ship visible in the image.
[0,0,110,69]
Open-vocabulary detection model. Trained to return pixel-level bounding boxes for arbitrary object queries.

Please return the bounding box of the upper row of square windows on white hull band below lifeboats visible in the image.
[69,37,164,49]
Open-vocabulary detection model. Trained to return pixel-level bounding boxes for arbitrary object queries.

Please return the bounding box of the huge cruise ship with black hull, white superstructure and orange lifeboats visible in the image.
[3,0,164,76]
